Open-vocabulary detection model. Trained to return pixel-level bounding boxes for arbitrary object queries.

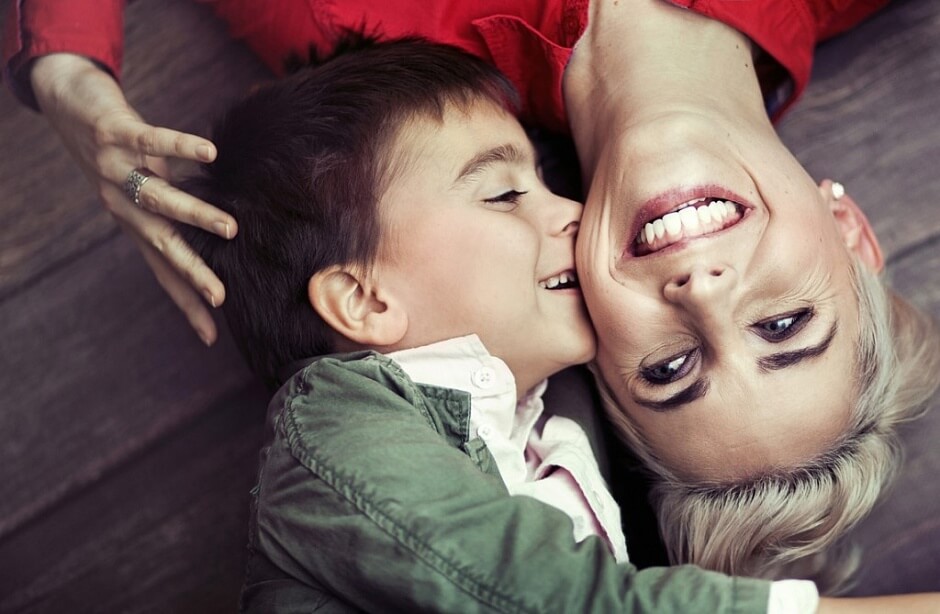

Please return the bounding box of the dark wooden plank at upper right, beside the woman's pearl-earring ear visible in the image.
[780,0,940,260]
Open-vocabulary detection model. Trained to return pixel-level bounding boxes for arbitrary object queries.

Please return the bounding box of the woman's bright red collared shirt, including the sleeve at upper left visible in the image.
[3,0,888,131]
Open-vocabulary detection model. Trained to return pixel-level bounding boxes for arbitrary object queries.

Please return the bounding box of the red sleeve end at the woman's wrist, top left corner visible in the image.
[3,0,125,109]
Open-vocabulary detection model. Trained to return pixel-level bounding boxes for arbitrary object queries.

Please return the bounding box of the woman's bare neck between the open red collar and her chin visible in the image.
[564,0,772,180]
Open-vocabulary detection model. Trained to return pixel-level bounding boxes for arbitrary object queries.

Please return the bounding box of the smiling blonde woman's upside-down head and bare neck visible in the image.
[565,1,940,588]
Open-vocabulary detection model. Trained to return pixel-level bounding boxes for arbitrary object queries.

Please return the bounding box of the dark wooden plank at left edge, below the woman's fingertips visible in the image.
[0,236,264,536]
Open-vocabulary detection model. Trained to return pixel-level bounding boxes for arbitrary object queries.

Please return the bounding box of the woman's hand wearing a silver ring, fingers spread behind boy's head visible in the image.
[30,53,238,345]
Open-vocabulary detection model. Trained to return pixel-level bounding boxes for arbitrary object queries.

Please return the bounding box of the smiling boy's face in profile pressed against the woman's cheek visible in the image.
[374,102,594,394]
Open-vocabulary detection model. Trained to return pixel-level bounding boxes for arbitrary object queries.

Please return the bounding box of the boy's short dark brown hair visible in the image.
[182,35,518,385]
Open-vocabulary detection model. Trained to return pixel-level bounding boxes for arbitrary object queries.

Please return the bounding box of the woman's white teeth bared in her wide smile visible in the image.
[632,197,746,257]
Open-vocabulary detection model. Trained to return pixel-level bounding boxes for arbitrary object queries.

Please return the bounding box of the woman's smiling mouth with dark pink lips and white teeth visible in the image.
[625,186,751,257]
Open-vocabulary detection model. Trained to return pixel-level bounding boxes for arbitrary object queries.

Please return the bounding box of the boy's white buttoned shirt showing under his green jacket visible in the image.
[388,335,628,562]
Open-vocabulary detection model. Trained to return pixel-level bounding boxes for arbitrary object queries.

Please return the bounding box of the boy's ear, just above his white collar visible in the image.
[307,265,408,346]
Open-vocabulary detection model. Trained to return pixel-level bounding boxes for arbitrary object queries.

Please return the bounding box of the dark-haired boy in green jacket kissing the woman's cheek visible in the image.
[187,40,815,612]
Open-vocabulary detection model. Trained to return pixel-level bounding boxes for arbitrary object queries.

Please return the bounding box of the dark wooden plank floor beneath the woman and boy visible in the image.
[0,0,940,613]
